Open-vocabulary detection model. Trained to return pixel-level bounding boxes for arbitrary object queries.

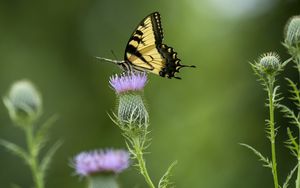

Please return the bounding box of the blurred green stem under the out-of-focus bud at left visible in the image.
[25,125,44,188]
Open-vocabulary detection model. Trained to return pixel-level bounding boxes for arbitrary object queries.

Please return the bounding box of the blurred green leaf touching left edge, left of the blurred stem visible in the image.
[0,139,29,164]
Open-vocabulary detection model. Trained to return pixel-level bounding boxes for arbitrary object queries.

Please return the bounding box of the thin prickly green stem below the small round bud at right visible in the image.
[268,79,279,188]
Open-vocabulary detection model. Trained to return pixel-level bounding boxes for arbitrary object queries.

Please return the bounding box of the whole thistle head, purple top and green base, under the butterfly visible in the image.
[109,72,149,126]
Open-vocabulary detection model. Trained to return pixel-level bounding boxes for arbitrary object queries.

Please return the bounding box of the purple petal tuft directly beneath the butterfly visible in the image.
[109,72,147,94]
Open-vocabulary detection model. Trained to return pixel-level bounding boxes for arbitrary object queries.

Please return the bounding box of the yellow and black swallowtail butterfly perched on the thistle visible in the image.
[97,12,195,79]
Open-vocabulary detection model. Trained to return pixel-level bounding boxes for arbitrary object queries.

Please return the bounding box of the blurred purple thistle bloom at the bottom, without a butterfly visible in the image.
[73,149,130,176]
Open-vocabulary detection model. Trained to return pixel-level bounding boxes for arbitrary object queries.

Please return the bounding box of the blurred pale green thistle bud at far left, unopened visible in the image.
[3,80,42,126]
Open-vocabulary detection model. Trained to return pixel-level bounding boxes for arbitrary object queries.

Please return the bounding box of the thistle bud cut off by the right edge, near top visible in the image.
[285,16,300,47]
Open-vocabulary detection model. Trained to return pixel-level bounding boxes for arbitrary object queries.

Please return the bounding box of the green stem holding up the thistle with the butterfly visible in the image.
[133,138,155,188]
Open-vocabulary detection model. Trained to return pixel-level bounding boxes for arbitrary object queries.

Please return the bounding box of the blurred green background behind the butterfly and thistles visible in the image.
[0,0,300,188]
